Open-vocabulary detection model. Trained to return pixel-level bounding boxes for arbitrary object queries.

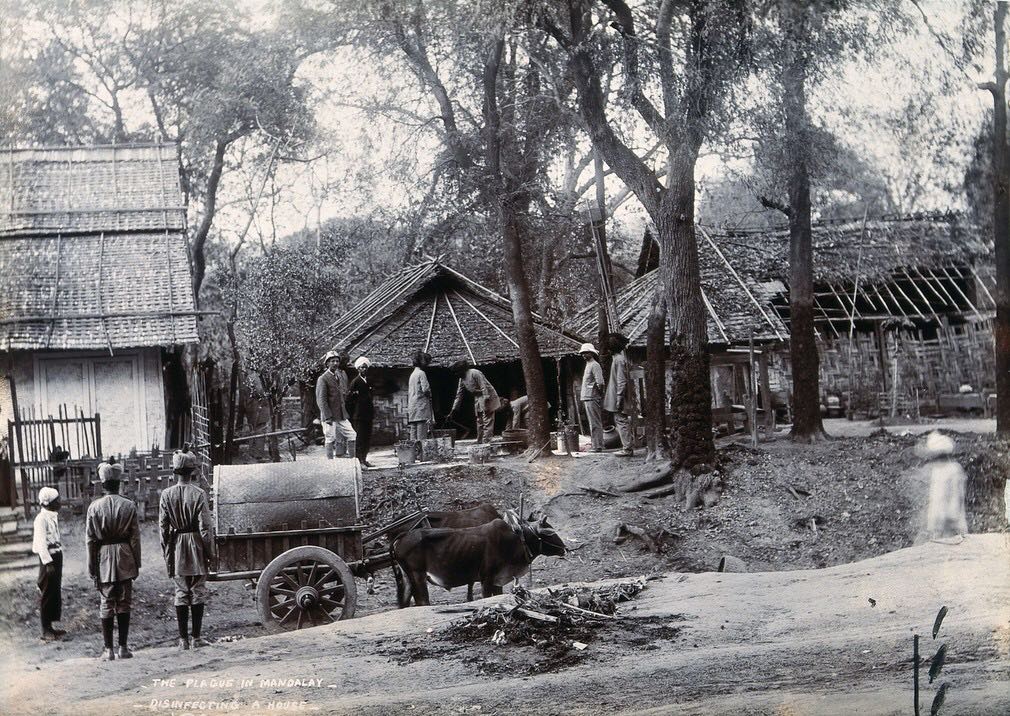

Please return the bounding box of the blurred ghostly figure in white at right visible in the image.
[917,430,968,539]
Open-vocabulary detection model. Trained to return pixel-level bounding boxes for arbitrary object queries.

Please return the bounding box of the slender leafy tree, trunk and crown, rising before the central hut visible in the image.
[305,0,589,446]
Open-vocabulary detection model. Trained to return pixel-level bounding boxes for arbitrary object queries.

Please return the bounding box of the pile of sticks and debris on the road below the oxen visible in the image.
[447,578,645,651]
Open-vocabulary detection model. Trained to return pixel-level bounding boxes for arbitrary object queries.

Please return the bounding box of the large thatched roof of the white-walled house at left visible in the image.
[0,144,198,350]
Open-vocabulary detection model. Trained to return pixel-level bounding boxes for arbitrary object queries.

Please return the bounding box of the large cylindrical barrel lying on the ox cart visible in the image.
[214,458,362,534]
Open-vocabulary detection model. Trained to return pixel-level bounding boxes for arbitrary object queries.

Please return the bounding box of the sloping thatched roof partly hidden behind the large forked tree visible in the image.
[574,229,789,347]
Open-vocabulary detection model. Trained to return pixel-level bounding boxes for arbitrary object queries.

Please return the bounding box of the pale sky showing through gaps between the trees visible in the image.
[7,0,991,245]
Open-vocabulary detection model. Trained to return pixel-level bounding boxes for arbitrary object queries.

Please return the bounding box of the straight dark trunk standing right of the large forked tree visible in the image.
[783,3,824,442]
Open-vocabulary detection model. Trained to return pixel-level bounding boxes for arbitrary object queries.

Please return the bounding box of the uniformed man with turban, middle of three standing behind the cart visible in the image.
[85,457,140,661]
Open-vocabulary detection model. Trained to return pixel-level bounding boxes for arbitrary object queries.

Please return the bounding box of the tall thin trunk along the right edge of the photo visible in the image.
[989,2,1010,434]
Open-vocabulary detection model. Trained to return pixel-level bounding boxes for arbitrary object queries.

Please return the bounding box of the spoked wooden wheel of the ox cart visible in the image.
[256,545,358,631]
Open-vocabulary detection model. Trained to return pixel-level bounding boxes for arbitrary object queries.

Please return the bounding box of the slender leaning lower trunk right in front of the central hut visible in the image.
[499,197,550,448]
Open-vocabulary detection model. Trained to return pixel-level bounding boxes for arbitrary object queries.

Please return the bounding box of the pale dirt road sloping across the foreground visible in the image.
[0,534,1010,716]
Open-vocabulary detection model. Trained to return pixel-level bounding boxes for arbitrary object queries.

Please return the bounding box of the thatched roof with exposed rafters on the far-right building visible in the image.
[712,214,995,337]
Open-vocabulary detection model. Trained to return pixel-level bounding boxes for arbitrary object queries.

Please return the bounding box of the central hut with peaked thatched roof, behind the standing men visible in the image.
[315,259,581,444]
